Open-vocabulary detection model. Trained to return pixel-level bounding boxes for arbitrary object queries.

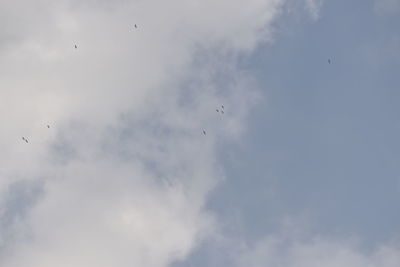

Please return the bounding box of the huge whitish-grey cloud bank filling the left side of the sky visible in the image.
[0,0,282,267]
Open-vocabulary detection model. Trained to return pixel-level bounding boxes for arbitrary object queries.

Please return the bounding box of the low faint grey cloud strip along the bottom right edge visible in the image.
[237,236,400,267]
